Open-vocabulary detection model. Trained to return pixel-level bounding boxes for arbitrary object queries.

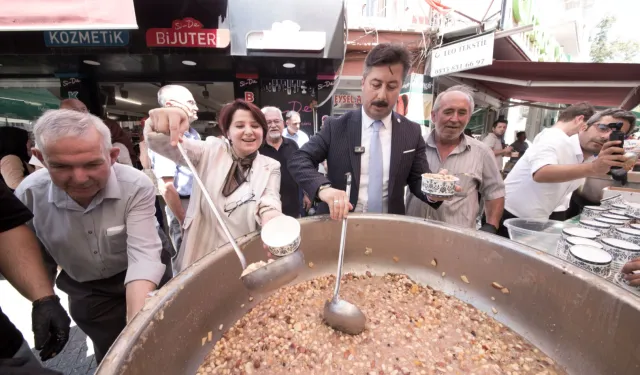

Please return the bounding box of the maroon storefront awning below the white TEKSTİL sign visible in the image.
[450,60,640,109]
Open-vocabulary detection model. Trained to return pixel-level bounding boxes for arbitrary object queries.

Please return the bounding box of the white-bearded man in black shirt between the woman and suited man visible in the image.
[260,107,304,217]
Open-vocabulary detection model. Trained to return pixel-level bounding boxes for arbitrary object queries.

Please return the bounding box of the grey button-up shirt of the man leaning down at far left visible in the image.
[15,163,165,285]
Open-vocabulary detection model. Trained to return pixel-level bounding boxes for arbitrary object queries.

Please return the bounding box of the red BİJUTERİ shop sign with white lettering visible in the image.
[146,17,231,48]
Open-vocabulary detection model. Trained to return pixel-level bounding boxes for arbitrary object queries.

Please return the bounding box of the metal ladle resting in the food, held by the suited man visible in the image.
[323,173,367,335]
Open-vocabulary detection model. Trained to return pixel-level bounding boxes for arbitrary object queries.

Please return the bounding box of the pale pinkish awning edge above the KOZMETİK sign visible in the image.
[0,0,138,31]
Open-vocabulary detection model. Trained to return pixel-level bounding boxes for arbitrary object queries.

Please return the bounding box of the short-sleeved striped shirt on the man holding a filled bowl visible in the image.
[406,131,505,229]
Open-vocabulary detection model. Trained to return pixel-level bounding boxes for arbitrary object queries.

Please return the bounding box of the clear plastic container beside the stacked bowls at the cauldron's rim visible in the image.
[504,219,573,254]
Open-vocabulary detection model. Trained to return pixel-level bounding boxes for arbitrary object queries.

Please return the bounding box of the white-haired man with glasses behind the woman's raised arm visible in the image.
[149,85,200,257]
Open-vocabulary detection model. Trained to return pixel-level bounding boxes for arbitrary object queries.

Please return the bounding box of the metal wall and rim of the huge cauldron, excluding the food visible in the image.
[97,215,640,375]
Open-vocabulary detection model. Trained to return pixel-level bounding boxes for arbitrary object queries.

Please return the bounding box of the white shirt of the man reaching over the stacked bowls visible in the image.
[504,128,584,219]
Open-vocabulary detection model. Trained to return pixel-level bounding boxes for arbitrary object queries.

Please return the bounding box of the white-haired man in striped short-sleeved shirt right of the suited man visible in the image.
[406,86,505,234]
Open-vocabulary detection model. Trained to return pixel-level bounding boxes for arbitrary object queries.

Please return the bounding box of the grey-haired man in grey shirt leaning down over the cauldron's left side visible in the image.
[15,110,165,363]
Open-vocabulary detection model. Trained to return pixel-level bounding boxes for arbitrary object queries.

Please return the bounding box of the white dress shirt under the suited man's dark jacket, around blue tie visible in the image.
[355,109,392,213]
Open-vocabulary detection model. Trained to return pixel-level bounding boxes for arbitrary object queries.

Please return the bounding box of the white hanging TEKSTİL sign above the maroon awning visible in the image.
[431,32,495,77]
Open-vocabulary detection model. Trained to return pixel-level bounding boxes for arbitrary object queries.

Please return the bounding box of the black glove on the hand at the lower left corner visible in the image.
[31,295,71,361]
